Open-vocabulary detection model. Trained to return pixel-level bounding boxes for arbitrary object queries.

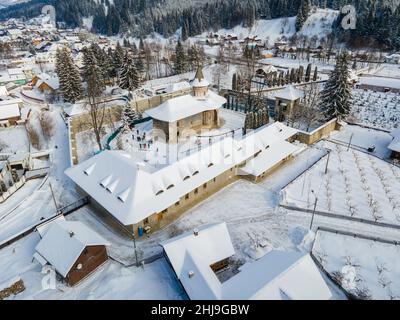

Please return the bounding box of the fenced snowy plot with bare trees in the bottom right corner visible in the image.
[313,231,400,300]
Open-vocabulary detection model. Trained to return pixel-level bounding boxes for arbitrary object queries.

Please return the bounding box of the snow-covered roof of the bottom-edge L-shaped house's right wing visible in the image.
[223,250,332,300]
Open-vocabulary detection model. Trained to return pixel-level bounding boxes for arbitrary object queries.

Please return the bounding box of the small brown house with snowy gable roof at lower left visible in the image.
[33,219,109,286]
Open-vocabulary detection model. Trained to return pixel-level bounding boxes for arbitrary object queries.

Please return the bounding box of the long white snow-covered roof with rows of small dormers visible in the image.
[65,122,297,225]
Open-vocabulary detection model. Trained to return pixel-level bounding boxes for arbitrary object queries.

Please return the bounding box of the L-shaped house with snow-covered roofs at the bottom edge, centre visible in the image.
[160,223,332,300]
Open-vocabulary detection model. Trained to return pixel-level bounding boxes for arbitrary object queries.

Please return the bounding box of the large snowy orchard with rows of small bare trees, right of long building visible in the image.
[284,142,400,224]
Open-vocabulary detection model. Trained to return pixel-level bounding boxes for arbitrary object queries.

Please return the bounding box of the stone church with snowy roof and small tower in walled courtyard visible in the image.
[146,68,227,143]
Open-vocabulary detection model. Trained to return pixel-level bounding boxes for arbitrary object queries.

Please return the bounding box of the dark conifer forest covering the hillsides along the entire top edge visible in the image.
[0,0,400,48]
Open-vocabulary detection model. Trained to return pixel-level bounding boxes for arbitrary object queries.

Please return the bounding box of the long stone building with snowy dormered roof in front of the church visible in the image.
[65,122,299,237]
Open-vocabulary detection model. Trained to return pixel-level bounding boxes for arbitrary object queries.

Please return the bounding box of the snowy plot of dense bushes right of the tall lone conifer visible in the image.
[349,89,400,130]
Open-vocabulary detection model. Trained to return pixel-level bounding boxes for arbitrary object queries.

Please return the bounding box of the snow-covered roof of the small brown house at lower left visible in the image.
[35,221,109,277]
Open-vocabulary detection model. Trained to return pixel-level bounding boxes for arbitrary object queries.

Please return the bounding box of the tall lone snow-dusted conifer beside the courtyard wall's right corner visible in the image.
[321,53,351,119]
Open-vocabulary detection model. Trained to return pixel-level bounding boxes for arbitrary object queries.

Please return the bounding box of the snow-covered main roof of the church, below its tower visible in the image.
[146,90,226,122]
